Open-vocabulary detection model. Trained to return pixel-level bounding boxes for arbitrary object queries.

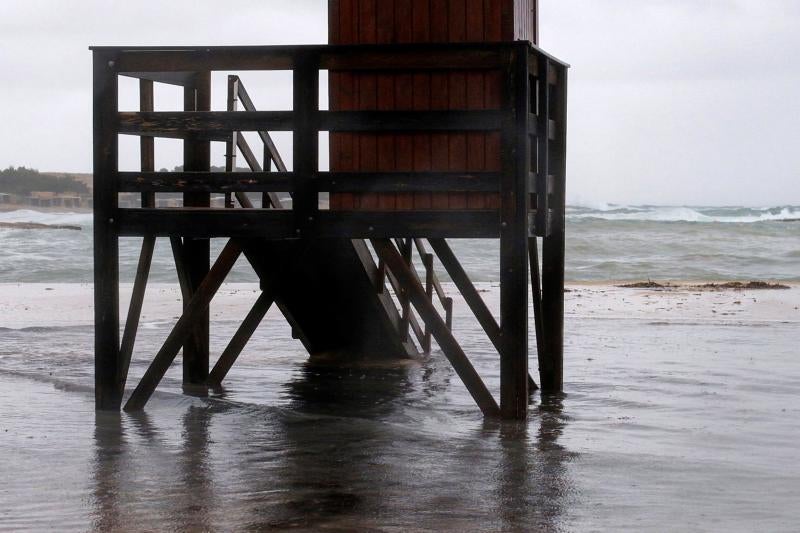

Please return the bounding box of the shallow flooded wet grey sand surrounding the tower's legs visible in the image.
[0,283,800,531]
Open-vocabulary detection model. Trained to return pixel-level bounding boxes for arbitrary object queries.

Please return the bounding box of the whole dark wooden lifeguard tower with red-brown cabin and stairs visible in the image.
[92,0,568,419]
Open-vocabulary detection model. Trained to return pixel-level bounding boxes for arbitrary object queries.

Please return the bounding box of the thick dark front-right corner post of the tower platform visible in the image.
[500,43,530,420]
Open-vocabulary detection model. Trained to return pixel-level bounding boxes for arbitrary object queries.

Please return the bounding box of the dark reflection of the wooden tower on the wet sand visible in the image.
[93,364,572,531]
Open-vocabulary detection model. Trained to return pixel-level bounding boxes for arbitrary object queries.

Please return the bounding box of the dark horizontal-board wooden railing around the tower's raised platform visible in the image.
[94,42,567,238]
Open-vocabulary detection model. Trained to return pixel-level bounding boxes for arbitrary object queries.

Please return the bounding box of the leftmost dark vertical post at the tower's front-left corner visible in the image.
[93,50,122,410]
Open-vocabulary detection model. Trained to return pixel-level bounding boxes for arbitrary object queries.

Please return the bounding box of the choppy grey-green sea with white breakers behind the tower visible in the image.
[0,205,800,283]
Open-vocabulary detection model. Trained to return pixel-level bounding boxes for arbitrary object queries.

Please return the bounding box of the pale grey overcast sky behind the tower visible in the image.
[0,0,800,205]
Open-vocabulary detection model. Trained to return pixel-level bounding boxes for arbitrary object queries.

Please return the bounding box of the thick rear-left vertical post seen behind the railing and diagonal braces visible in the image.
[183,71,211,385]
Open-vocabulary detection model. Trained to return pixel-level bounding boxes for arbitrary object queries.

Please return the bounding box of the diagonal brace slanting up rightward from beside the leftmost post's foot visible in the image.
[125,240,242,411]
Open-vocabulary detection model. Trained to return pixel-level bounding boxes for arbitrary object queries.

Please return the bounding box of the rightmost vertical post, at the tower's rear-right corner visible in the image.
[539,64,567,393]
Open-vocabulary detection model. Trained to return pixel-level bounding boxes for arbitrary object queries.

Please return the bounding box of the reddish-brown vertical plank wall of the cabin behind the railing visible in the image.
[328,0,537,210]
